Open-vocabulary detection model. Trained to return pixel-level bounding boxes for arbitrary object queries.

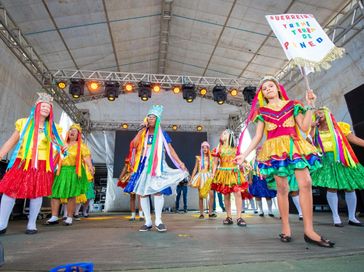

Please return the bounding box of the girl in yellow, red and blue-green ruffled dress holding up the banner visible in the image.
[236,77,334,247]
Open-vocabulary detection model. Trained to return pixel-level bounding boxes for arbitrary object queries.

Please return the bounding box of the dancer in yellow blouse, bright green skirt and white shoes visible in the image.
[47,124,94,225]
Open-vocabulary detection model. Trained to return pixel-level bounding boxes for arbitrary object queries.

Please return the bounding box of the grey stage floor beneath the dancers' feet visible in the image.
[1,211,364,272]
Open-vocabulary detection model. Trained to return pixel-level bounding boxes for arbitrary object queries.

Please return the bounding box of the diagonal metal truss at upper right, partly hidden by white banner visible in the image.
[276,0,364,90]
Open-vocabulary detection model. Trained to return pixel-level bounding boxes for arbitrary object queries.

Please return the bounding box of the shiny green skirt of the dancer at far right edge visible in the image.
[311,152,364,191]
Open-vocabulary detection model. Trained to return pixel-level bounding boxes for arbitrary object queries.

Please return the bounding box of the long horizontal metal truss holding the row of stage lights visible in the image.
[53,69,258,107]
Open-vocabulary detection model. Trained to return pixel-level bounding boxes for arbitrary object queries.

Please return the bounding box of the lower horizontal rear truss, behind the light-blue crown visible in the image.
[90,121,226,132]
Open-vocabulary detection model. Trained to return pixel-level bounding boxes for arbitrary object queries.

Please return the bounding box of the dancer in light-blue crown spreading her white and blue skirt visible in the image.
[124,105,189,232]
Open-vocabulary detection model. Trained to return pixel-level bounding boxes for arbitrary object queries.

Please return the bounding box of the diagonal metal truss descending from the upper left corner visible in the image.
[0,6,88,128]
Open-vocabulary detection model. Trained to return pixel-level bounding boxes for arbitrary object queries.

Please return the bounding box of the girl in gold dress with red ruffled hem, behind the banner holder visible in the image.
[211,129,248,227]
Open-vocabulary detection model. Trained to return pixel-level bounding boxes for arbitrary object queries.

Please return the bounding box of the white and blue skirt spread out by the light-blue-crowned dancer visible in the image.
[124,151,189,196]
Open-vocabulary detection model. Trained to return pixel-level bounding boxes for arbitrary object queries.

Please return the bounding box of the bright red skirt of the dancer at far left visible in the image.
[0,158,54,199]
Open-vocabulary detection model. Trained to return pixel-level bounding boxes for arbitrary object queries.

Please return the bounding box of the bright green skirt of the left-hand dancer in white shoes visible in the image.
[51,166,89,198]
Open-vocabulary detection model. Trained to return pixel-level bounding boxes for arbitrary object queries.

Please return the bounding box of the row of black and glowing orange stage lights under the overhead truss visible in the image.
[57,79,256,105]
